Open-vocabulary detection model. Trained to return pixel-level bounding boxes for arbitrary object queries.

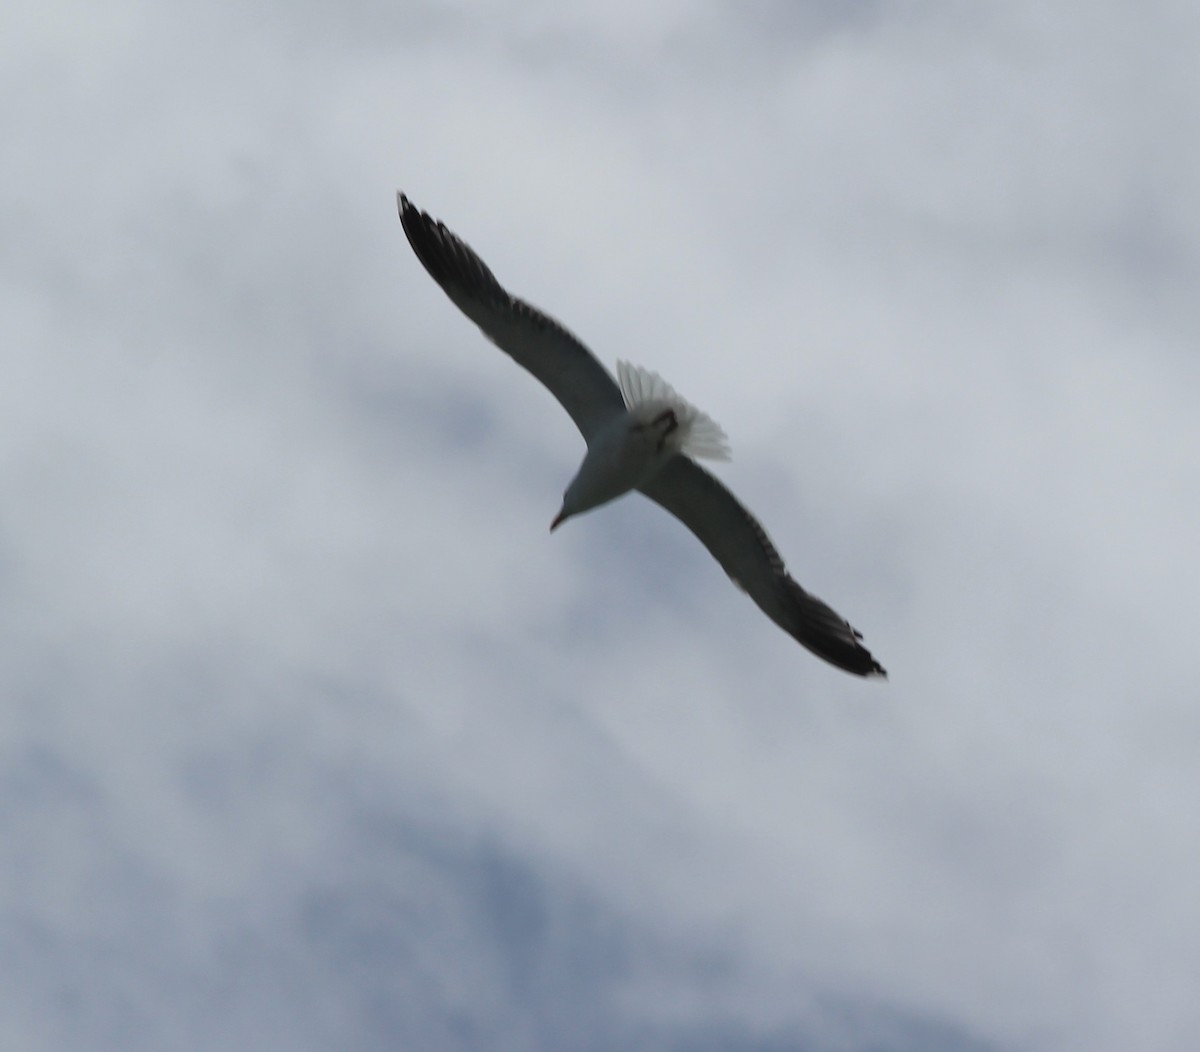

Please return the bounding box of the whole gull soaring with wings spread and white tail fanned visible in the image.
[396,193,887,677]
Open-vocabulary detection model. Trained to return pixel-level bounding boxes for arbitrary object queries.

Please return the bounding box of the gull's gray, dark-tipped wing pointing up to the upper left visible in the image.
[396,193,625,439]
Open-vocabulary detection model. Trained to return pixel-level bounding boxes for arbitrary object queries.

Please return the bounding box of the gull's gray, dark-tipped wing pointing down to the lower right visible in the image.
[638,455,887,677]
